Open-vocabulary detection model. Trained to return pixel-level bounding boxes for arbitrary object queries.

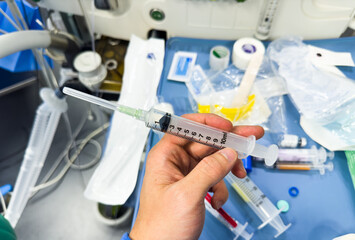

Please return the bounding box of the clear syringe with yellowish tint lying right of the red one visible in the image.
[225,173,291,238]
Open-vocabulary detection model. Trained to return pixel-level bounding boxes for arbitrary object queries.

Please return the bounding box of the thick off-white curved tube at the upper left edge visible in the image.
[0,30,52,58]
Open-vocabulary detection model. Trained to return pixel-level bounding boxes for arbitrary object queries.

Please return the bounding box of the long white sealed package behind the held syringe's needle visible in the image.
[84,36,164,205]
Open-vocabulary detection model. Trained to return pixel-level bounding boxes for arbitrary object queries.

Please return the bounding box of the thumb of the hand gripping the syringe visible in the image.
[183,148,238,197]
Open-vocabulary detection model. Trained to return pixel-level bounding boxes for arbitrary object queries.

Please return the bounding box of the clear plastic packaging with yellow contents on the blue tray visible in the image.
[186,65,271,124]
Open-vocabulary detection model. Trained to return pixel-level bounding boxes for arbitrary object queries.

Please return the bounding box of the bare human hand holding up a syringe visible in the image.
[130,114,264,240]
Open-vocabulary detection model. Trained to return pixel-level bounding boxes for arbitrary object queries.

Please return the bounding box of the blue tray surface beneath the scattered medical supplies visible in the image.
[133,37,355,240]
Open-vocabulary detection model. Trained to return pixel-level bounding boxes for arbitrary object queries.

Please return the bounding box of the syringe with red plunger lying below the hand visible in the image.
[205,193,253,240]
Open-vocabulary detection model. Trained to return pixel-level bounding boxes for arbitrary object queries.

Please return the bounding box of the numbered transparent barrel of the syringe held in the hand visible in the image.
[145,109,255,155]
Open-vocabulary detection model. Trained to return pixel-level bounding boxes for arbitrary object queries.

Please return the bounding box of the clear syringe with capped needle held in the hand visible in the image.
[63,87,278,166]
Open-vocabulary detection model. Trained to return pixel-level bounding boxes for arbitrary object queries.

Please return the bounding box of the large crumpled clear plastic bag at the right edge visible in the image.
[267,37,355,149]
